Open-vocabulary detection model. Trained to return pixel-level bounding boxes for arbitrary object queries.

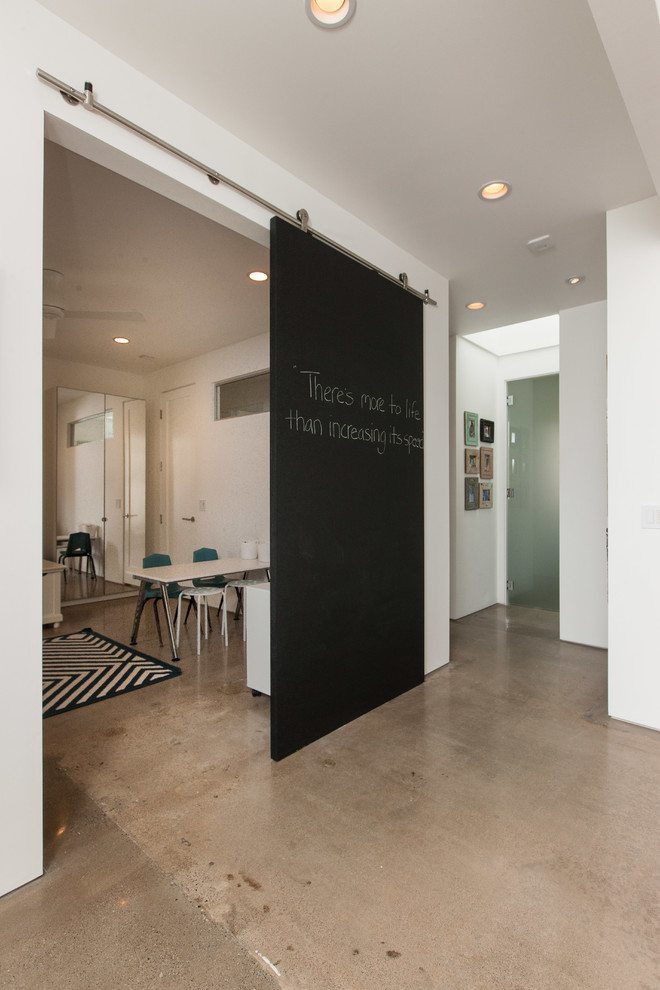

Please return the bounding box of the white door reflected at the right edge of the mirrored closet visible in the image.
[124,399,147,584]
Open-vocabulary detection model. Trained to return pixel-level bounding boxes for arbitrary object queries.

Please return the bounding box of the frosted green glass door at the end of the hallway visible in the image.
[507,375,559,612]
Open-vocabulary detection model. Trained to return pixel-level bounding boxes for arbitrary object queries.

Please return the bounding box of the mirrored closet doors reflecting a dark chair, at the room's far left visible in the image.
[52,388,146,602]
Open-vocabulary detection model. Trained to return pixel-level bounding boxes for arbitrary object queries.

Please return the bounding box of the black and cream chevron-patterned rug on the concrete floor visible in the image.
[43,629,181,718]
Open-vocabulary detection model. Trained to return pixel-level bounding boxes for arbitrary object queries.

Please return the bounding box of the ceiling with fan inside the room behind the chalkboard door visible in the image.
[44,141,270,372]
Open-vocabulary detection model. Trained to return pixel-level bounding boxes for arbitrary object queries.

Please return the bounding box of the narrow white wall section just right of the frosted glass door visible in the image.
[559,302,607,648]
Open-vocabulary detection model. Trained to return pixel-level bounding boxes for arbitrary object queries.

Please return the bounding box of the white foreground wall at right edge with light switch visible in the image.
[607,197,660,729]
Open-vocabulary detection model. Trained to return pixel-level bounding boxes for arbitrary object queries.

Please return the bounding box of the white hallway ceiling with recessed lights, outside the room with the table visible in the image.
[42,0,658,368]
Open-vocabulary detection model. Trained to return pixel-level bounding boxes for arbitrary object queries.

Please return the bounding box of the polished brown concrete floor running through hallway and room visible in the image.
[0,601,660,990]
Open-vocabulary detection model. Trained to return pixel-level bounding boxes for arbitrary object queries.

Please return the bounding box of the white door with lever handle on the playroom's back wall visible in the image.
[161,386,199,564]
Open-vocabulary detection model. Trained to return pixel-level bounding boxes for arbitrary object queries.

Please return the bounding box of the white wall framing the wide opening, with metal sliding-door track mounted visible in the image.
[0,0,449,893]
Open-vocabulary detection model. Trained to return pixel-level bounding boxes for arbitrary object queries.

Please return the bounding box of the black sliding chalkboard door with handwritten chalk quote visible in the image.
[271,219,424,760]
